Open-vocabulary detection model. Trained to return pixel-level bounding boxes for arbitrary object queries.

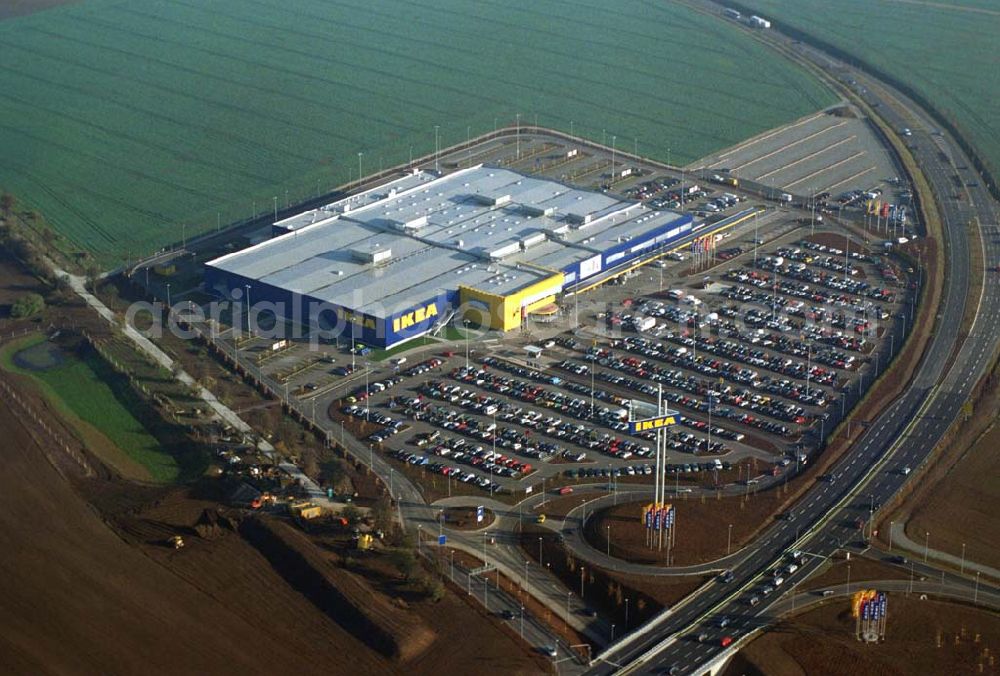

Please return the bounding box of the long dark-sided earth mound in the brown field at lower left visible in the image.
[240,517,435,662]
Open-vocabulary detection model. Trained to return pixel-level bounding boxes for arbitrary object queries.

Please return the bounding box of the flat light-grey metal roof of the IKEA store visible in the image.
[208,166,680,316]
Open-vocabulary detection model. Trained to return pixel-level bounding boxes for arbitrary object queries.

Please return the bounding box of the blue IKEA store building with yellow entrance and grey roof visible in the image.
[205,165,692,347]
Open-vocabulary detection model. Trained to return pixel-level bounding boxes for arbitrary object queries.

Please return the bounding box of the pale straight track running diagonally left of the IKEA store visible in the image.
[58,262,344,510]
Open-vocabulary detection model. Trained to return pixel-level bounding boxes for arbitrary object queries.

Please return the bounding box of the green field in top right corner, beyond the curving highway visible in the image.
[745,0,1000,185]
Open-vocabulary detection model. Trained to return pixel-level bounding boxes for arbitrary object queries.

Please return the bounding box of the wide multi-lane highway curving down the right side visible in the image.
[590,3,1000,674]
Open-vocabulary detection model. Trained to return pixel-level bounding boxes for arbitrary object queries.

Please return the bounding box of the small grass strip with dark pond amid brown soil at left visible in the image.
[0,335,181,483]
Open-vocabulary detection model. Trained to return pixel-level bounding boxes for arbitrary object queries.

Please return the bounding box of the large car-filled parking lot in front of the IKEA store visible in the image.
[322,219,908,500]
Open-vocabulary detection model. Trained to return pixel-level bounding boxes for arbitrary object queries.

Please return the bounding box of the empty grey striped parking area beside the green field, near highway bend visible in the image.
[698,107,899,195]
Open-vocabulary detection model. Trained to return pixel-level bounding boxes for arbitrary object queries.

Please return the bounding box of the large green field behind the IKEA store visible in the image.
[0,0,834,265]
